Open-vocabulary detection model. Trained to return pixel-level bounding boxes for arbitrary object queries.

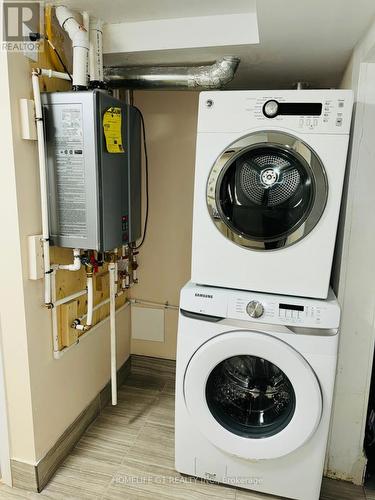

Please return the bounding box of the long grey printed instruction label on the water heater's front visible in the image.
[54,104,87,238]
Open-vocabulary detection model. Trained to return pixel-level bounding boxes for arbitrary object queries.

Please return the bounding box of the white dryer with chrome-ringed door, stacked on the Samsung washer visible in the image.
[192,90,353,298]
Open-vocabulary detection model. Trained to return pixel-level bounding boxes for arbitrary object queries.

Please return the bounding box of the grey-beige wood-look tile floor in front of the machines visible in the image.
[0,357,375,500]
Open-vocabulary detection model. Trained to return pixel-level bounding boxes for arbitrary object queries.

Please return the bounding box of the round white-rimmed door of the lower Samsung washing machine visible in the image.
[184,330,322,460]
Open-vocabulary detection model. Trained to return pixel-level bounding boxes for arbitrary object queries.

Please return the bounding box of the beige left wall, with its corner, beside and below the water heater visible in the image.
[0,54,130,463]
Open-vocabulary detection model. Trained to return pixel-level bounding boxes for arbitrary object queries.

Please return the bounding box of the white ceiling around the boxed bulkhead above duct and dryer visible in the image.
[48,0,375,89]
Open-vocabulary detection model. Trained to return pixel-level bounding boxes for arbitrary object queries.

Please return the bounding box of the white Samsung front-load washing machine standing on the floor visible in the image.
[175,283,340,500]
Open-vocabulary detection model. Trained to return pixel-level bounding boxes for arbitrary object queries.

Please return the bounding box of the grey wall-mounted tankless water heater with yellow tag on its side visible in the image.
[42,90,141,251]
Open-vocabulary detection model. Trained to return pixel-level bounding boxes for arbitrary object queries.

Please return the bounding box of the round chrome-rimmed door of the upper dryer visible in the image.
[207,131,328,250]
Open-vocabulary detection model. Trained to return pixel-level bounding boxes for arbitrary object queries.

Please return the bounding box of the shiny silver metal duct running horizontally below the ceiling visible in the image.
[104,56,240,90]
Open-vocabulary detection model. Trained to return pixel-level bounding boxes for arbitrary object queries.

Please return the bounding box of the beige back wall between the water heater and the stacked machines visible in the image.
[131,91,199,359]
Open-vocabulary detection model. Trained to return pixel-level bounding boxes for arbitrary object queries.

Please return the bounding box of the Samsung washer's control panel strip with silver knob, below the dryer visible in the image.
[180,283,340,329]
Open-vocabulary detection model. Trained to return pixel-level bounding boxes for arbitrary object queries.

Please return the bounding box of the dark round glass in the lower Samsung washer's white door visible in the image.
[206,356,296,438]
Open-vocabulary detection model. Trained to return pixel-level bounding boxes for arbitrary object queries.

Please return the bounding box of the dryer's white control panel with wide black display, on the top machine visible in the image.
[198,90,353,134]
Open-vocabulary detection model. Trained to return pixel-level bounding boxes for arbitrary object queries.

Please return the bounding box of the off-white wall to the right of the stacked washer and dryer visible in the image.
[327,18,375,484]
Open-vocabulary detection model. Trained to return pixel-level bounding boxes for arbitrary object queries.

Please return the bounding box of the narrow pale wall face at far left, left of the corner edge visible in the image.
[0,52,34,460]
